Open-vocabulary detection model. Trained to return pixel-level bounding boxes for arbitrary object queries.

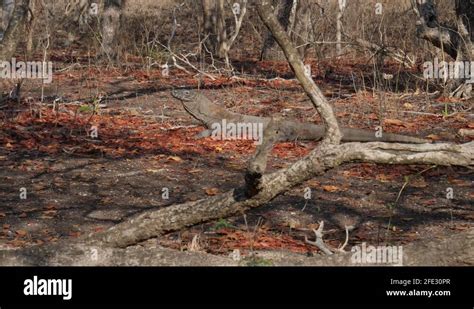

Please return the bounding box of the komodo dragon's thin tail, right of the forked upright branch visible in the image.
[341,128,431,144]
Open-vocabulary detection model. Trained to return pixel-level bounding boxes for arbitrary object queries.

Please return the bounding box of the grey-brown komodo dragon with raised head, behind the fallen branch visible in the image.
[171,89,431,144]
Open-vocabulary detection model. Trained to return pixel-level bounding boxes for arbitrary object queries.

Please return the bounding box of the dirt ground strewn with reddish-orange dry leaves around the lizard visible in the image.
[0,57,474,264]
